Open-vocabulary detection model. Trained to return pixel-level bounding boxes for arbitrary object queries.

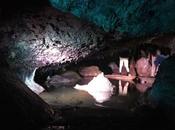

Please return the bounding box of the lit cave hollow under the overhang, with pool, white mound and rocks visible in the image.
[35,44,164,110]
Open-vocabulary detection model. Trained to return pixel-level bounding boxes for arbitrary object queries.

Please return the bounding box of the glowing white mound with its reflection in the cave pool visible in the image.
[74,73,115,103]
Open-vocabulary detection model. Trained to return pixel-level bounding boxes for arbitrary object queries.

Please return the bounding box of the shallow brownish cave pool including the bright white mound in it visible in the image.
[40,74,152,109]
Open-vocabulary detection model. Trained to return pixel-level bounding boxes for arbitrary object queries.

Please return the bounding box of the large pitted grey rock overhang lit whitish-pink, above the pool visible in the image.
[0,7,104,79]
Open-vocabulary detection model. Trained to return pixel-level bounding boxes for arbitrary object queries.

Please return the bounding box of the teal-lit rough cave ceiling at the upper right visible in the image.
[50,0,175,37]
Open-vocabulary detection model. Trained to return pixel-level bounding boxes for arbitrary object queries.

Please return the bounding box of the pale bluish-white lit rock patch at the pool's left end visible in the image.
[25,68,44,94]
